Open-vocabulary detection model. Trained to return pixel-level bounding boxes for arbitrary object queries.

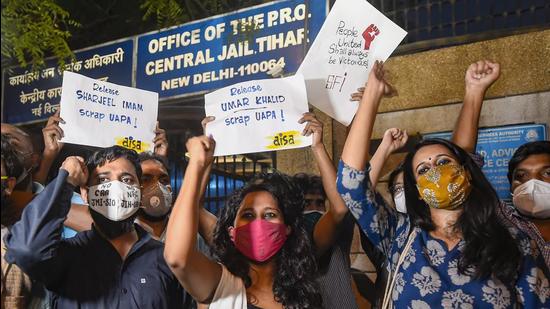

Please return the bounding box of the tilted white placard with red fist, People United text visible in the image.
[298,0,407,125]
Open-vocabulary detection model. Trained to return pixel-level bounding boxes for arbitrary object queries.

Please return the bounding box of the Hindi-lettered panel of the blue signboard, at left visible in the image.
[2,39,134,124]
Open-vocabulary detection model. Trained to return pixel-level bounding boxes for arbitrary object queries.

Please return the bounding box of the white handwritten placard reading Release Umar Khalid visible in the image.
[205,75,311,156]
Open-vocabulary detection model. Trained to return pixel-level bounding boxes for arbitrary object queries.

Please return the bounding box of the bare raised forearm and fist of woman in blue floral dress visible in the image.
[342,61,393,170]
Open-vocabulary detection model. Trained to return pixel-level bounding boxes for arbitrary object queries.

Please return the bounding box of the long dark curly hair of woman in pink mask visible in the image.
[212,172,322,309]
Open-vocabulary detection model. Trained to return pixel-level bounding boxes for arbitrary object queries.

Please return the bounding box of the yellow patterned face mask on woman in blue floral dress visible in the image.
[416,164,471,210]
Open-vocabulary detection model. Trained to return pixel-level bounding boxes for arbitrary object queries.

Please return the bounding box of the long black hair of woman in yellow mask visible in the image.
[404,139,521,282]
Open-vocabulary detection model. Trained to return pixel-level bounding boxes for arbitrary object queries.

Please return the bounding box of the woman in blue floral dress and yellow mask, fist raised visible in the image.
[337,59,550,308]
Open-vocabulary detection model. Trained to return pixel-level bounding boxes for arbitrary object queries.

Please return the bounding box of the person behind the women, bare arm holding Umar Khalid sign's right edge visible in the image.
[293,113,358,309]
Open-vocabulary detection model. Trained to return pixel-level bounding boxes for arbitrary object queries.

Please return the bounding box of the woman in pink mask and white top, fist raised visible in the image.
[164,136,321,309]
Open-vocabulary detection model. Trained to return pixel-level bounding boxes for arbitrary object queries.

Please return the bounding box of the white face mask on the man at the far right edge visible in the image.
[512,179,550,219]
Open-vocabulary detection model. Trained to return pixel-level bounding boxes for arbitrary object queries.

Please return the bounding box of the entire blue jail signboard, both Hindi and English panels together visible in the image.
[2,0,328,124]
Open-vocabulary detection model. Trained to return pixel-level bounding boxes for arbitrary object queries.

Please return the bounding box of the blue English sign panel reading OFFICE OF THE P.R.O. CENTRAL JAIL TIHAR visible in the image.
[136,0,327,98]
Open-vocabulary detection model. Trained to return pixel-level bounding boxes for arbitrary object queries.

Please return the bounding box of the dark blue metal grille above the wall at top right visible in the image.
[368,0,550,53]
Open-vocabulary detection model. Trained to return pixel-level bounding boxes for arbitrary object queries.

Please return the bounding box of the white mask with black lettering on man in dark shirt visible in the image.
[88,180,141,221]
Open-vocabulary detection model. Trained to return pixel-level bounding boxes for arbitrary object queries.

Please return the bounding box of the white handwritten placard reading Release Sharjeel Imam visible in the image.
[60,71,158,152]
